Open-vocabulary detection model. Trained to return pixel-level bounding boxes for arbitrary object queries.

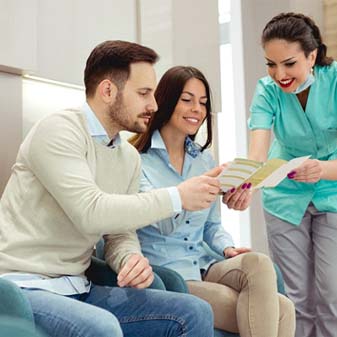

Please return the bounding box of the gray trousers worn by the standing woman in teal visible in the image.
[265,204,337,337]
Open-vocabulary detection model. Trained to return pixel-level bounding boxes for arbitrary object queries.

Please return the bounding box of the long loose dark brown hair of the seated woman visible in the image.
[130,66,212,152]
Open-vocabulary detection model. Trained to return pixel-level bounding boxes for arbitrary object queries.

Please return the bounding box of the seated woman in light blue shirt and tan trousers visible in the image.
[131,66,295,337]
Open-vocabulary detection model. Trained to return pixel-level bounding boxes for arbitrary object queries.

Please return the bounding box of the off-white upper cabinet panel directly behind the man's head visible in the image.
[35,0,137,85]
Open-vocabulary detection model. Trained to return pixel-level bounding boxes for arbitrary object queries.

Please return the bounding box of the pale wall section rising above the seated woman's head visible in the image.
[140,0,221,111]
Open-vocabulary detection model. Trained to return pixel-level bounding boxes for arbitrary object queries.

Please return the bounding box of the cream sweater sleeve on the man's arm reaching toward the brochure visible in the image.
[25,114,173,234]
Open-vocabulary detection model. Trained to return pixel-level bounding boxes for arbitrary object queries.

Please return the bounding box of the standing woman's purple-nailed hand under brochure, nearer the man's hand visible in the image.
[222,183,252,211]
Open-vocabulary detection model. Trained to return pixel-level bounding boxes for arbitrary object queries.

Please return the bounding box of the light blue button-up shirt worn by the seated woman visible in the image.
[137,131,234,280]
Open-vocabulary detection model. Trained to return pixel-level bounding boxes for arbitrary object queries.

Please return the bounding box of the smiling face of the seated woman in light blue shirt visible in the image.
[167,78,207,136]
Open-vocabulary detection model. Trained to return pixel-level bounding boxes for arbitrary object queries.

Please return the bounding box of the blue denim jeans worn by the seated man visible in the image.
[25,285,213,337]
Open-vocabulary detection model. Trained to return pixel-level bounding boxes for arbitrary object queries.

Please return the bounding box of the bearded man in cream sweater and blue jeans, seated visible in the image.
[0,41,219,337]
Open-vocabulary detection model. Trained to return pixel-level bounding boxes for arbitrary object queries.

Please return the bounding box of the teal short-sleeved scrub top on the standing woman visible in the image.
[248,61,337,225]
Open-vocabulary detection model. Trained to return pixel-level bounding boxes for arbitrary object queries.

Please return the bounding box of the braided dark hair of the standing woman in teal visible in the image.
[261,13,333,66]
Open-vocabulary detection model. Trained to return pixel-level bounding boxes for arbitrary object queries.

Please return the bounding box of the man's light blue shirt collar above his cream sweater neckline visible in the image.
[82,102,121,147]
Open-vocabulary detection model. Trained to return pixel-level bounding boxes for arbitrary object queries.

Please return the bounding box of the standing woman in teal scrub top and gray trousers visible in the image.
[245,13,337,337]
